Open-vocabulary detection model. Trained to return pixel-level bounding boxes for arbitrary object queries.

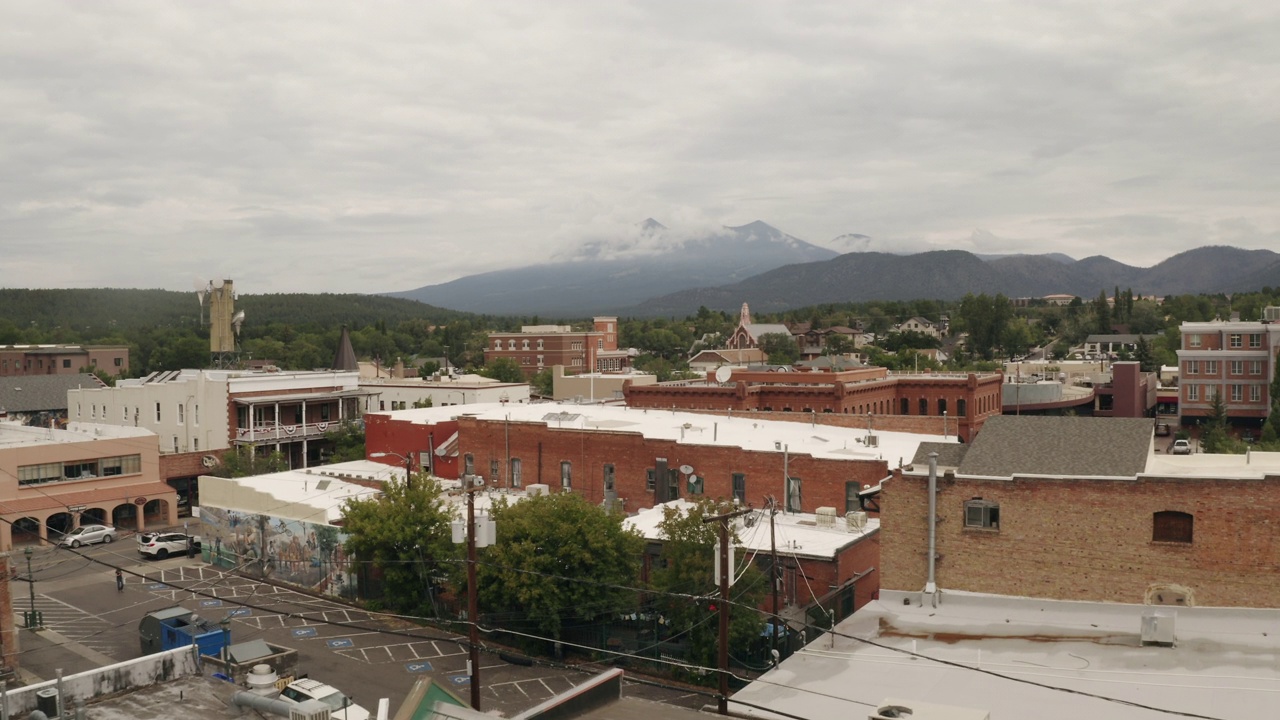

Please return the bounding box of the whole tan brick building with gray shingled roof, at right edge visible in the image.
[879,416,1280,607]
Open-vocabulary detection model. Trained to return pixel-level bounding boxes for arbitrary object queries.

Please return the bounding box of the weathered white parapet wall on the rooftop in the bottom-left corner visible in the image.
[8,647,200,717]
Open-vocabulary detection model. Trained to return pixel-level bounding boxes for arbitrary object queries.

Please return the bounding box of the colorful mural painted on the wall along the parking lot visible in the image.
[200,506,356,596]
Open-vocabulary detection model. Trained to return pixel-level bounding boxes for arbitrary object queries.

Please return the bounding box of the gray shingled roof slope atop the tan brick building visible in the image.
[959,415,1155,478]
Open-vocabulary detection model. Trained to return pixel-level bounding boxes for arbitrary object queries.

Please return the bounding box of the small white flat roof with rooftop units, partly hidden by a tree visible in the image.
[622,500,879,560]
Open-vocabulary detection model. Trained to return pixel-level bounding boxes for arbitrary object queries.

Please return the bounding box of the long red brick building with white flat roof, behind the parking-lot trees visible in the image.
[365,404,954,515]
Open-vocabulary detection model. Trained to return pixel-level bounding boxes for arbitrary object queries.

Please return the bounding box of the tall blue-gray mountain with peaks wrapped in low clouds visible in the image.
[388,218,837,316]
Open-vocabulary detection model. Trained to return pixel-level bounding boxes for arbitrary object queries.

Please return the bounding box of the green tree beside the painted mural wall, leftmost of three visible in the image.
[343,473,458,616]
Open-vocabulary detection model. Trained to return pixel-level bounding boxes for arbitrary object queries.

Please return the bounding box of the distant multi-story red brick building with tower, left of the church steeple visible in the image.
[484,316,631,378]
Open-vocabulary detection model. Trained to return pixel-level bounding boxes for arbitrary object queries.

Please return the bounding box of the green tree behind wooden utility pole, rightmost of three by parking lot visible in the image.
[650,498,768,666]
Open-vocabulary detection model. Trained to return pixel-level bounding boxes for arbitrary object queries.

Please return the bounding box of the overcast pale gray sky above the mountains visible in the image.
[0,0,1280,293]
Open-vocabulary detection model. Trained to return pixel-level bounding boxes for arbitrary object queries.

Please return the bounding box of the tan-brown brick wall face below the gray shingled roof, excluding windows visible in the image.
[881,473,1280,607]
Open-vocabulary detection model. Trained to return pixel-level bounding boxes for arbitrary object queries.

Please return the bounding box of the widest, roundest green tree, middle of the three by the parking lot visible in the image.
[476,492,644,641]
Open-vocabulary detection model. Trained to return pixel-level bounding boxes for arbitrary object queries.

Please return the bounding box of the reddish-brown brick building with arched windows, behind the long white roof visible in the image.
[623,368,1004,441]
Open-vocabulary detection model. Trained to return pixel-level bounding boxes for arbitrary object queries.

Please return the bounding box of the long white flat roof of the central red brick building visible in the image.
[370,402,959,466]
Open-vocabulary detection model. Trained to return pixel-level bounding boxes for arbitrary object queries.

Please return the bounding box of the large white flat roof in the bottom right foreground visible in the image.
[730,591,1280,720]
